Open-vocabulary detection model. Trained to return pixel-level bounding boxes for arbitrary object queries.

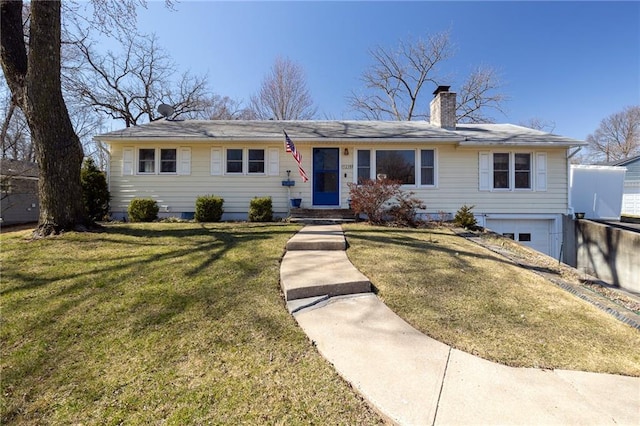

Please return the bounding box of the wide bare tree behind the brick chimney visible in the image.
[347,31,506,123]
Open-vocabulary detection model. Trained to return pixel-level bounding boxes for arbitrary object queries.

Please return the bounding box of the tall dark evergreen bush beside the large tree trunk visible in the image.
[80,158,111,222]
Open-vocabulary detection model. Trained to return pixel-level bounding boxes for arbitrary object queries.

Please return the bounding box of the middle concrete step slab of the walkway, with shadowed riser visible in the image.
[280,250,371,302]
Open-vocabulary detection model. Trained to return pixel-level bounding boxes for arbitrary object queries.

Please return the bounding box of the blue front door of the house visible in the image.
[313,148,340,206]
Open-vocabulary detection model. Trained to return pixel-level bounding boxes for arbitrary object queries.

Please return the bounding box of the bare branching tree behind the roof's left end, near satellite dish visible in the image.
[65,33,211,127]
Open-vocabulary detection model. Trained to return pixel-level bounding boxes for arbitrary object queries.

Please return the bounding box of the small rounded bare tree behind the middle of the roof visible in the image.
[250,57,316,120]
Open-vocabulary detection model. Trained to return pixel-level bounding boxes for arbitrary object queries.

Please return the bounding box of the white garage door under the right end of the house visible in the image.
[487,219,553,255]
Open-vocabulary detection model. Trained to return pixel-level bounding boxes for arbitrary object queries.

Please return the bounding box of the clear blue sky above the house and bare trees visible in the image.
[124,0,640,139]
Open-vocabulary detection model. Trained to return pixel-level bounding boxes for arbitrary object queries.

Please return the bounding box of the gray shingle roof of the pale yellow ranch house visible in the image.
[95,120,584,146]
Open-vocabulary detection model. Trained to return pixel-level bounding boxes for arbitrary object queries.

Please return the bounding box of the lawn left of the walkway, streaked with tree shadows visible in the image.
[0,224,380,425]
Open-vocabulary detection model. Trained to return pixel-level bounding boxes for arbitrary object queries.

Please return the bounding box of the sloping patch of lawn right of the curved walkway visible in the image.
[344,224,640,376]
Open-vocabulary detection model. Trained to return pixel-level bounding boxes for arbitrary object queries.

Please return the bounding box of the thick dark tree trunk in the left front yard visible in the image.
[1,0,88,236]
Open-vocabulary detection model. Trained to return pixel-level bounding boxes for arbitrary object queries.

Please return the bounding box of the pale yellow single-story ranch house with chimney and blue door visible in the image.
[96,86,585,257]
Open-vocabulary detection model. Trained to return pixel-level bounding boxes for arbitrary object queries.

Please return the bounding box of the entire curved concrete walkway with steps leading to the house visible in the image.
[281,225,640,425]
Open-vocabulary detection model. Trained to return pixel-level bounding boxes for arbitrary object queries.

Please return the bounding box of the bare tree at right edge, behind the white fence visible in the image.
[587,105,640,162]
